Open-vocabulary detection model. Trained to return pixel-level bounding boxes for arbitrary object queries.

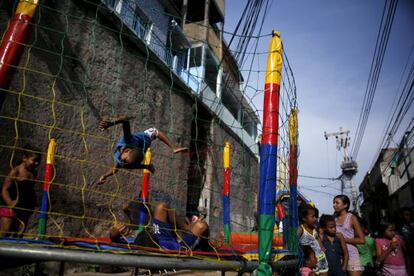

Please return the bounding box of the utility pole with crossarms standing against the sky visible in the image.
[324,127,361,215]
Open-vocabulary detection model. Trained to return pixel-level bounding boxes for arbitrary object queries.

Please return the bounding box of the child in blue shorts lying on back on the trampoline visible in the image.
[109,202,223,251]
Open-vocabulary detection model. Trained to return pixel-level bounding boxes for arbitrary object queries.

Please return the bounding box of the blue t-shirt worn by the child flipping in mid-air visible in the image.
[114,132,152,167]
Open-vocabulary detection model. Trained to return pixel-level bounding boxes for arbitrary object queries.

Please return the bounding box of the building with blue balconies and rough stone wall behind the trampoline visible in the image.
[0,0,260,236]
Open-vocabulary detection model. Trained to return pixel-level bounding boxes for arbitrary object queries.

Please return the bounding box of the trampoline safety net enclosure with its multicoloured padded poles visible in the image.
[0,0,299,275]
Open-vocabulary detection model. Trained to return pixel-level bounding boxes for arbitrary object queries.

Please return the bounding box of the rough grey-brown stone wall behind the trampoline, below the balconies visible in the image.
[0,1,258,236]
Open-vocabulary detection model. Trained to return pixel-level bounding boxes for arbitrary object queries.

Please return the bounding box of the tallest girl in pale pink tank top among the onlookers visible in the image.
[333,195,365,276]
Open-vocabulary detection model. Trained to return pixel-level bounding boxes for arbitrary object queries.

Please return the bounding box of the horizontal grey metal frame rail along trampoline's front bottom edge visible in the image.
[0,244,298,271]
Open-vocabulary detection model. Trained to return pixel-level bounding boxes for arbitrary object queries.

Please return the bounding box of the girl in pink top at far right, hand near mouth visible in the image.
[375,223,408,276]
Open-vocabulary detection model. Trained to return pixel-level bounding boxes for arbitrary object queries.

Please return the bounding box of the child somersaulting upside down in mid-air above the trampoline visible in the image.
[98,116,188,184]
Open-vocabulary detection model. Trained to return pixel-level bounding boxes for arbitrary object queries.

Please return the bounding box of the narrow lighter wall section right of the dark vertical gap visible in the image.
[210,121,259,232]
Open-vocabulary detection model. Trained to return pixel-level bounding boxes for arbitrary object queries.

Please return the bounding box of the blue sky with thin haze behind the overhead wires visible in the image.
[224,0,414,213]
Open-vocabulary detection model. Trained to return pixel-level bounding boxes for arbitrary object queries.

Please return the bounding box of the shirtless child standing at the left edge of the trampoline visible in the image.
[0,145,41,237]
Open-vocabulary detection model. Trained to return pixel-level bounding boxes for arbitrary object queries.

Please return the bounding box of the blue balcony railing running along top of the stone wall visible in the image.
[101,0,200,93]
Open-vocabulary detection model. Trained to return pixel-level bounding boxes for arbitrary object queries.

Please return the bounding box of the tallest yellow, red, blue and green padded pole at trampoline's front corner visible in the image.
[257,33,283,276]
